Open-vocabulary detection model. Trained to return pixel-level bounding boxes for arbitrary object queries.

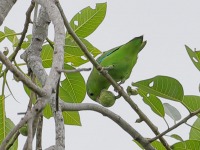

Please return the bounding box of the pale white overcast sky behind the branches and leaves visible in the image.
[0,0,200,150]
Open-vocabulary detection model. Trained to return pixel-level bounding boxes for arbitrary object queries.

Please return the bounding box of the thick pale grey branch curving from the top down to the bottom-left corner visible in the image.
[0,0,65,150]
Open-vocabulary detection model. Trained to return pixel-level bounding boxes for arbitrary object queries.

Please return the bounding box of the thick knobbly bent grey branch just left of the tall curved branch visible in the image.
[20,7,51,86]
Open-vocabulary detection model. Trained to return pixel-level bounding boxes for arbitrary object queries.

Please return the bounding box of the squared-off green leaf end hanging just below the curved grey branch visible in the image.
[63,111,81,126]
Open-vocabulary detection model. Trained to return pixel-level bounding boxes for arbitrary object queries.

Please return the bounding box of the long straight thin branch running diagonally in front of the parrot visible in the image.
[56,0,171,150]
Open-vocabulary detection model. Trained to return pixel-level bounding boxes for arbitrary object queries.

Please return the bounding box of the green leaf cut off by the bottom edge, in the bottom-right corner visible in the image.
[171,140,200,150]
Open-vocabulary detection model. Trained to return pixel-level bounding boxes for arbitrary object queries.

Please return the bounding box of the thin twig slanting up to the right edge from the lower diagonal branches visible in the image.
[149,109,200,142]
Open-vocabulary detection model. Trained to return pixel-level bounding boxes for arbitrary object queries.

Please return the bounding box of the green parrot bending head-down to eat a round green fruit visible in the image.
[86,36,146,101]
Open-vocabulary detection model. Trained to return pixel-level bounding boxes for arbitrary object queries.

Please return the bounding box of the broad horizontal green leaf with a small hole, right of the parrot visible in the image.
[132,76,183,102]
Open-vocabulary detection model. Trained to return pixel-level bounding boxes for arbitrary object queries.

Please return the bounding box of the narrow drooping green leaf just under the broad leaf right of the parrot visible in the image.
[138,89,165,117]
